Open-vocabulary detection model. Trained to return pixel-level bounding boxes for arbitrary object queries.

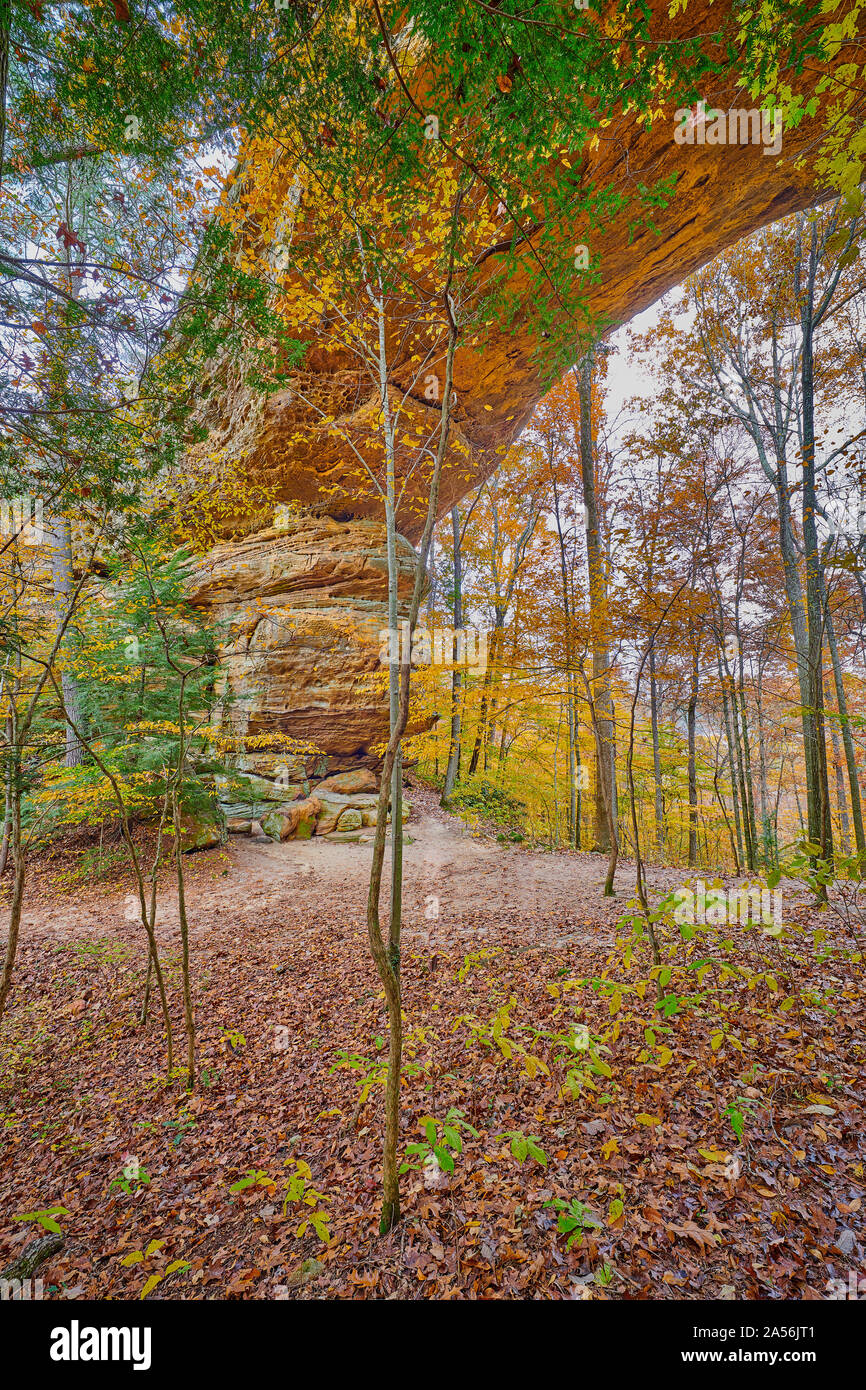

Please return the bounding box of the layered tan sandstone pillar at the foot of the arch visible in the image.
[189,517,416,761]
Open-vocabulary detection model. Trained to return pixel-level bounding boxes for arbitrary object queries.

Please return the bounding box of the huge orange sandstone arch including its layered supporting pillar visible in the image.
[189,0,845,770]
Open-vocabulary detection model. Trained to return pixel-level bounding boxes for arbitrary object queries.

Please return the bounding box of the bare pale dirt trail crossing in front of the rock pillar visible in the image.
[11,787,733,949]
